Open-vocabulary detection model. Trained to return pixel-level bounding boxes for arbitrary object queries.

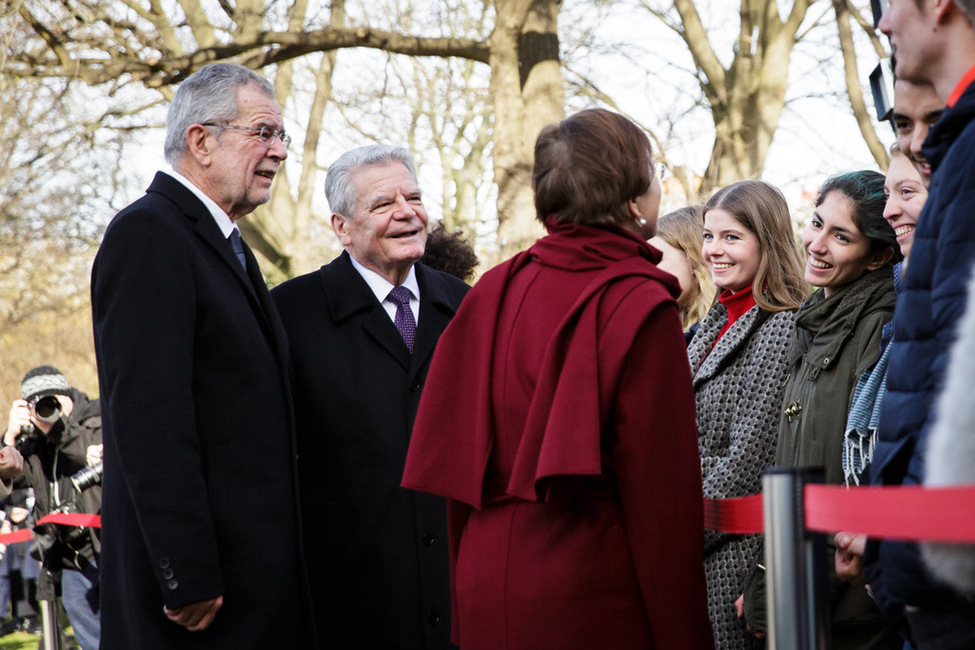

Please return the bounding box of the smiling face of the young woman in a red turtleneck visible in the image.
[701,208,762,292]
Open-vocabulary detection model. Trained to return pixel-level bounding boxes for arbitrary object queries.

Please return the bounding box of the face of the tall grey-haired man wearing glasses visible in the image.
[203,84,288,221]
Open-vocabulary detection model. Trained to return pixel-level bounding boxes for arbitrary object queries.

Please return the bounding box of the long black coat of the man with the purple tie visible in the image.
[271,253,468,649]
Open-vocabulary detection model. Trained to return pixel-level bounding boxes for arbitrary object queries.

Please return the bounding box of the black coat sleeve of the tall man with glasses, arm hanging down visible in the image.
[92,204,224,608]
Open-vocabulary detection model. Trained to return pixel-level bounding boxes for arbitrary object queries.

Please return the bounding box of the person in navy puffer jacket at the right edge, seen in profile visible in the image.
[864,0,975,650]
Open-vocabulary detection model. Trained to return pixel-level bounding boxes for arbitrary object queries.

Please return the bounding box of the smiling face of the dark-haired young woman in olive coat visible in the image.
[802,191,883,298]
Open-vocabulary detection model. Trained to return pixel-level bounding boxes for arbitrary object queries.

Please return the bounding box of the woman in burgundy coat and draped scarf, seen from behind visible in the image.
[403,109,713,650]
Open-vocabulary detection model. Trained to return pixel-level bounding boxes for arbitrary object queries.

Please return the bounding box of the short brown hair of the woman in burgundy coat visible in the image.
[532,108,653,225]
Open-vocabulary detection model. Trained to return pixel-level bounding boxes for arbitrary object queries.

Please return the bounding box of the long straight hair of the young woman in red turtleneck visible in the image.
[704,181,809,311]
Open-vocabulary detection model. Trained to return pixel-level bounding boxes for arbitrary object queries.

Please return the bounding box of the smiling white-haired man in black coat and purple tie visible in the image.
[271,145,469,650]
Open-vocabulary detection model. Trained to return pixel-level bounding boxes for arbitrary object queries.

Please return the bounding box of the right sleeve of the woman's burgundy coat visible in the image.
[612,286,714,650]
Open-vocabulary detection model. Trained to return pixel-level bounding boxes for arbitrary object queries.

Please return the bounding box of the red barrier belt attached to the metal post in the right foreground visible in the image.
[704,484,975,544]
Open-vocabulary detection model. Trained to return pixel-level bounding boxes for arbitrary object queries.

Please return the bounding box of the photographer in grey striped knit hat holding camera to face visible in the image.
[4,366,102,650]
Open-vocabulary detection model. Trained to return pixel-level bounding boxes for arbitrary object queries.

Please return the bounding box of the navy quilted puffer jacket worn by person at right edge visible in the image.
[864,79,975,616]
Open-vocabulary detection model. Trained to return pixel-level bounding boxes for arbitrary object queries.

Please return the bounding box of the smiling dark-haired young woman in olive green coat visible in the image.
[744,171,903,650]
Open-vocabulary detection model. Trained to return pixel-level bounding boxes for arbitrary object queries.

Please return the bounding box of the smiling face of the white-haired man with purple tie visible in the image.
[332,162,427,285]
